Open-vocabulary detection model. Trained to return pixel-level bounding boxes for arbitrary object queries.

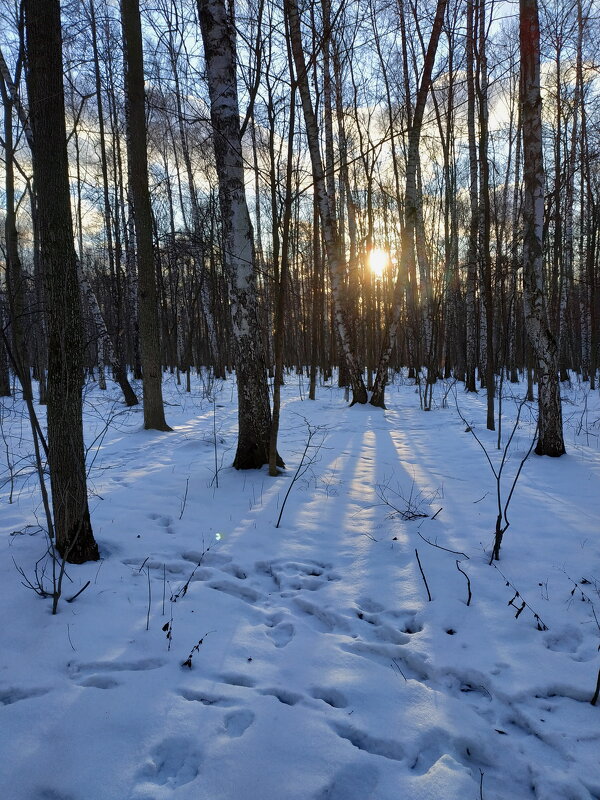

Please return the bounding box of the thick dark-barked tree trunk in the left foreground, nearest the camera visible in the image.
[24,0,99,563]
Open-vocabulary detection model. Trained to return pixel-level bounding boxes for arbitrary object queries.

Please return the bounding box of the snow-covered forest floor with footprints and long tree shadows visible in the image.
[0,375,600,800]
